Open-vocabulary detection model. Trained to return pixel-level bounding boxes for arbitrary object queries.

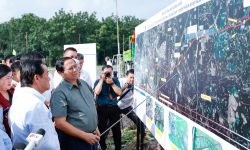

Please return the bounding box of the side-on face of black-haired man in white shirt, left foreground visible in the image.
[37,64,50,93]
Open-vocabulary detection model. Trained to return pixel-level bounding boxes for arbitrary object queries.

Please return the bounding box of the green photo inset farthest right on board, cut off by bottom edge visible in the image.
[193,127,222,150]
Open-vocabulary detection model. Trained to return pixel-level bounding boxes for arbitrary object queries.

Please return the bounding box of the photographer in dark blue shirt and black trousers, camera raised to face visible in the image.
[94,65,122,150]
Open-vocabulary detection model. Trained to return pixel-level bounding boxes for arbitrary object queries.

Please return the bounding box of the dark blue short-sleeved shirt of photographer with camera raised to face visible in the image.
[94,79,121,105]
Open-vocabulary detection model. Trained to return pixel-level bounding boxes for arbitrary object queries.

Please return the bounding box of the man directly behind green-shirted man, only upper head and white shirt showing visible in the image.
[54,47,77,88]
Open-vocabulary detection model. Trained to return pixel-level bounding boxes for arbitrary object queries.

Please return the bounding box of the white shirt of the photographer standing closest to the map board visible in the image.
[117,78,134,109]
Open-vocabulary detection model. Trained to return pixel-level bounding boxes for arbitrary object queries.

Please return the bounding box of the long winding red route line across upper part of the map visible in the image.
[148,18,250,73]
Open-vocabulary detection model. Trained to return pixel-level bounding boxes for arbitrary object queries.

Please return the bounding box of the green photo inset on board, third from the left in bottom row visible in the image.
[168,112,188,150]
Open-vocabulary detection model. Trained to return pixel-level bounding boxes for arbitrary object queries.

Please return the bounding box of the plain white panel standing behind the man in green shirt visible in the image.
[64,43,97,85]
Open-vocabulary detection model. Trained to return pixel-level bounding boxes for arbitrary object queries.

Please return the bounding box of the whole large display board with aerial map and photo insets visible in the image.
[134,0,250,150]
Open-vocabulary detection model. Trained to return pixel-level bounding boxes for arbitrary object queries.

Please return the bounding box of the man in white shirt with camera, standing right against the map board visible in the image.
[118,69,148,139]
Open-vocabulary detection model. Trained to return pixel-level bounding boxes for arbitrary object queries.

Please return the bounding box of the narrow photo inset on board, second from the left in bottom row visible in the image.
[155,102,164,133]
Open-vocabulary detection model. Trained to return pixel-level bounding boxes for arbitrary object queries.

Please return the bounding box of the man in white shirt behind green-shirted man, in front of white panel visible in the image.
[77,53,93,87]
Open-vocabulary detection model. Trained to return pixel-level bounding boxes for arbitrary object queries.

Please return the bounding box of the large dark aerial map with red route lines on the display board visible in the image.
[135,0,250,149]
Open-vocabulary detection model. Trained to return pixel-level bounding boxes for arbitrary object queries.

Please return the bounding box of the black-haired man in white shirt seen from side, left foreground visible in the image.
[8,60,60,150]
